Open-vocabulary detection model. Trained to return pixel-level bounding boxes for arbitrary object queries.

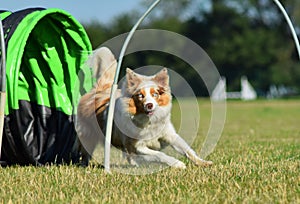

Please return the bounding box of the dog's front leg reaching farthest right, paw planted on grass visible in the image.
[169,134,213,166]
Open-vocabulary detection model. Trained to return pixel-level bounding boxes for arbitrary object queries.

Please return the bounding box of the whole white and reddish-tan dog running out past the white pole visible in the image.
[78,48,212,168]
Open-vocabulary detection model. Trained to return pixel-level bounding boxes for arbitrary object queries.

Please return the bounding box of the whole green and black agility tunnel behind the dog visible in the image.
[0,8,92,165]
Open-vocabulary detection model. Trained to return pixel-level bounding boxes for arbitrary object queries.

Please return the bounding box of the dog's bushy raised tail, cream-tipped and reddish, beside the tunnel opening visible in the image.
[78,47,117,118]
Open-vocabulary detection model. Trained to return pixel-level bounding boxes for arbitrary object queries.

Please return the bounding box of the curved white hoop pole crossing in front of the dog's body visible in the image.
[104,0,160,172]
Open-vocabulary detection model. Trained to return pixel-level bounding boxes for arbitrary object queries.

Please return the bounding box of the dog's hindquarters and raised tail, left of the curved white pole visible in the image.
[74,47,117,166]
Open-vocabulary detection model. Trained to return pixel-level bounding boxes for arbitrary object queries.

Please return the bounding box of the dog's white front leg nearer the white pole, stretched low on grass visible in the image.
[136,146,186,169]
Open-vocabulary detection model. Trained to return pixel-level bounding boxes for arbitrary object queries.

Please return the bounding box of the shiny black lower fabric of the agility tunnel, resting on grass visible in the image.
[3,101,78,165]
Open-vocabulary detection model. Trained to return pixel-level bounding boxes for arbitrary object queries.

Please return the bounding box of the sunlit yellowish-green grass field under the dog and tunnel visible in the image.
[0,99,300,203]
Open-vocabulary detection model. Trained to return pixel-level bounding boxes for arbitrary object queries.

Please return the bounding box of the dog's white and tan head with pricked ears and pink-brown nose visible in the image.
[123,68,172,117]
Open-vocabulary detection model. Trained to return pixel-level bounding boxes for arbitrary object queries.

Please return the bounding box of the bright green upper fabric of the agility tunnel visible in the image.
[5,9,91,114]
